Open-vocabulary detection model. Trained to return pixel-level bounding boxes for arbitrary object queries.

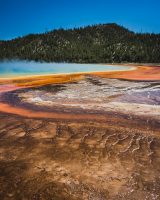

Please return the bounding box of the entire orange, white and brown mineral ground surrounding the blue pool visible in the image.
[0,66,160,200]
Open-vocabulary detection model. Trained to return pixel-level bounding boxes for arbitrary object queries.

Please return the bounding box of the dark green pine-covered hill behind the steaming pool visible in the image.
[0,24,160,63]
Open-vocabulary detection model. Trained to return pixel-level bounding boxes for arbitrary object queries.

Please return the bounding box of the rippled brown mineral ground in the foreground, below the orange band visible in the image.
[0,113,160,200]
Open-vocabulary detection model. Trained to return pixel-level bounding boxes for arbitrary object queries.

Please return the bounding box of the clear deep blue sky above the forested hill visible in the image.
[0,0,160,39]
